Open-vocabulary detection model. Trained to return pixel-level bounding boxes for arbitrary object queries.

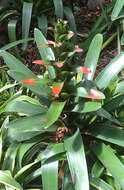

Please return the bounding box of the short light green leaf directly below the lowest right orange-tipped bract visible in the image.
[72,102,101,113]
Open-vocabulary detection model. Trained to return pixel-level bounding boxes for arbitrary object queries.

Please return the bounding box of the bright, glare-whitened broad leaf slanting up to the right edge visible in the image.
[96,53,124,89]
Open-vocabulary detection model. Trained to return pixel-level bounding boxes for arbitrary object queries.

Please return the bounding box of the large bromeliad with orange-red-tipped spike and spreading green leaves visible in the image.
[0,20,124,190]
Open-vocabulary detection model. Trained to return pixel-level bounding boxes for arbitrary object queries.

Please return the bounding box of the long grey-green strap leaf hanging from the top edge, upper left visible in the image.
[22,2,33,51]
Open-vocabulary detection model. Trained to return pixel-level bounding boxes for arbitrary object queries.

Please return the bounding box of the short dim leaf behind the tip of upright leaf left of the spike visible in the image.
[38,15,48,37]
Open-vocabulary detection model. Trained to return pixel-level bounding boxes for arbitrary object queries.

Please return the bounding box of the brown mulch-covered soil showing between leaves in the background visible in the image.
[0,0,117,74]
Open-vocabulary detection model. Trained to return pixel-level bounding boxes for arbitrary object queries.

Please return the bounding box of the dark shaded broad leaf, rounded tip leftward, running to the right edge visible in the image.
[89,124,124,147]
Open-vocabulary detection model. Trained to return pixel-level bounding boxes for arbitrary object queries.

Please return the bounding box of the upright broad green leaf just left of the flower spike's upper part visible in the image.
[34,28,55,61]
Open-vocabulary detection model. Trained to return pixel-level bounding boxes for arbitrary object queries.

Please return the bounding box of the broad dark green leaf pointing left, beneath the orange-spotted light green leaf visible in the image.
[7,114,57,141]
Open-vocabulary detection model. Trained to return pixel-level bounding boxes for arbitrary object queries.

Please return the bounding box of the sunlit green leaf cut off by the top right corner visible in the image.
[111,0,124,21]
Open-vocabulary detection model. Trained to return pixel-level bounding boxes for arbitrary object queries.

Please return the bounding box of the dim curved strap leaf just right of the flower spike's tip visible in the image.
[64,7,77,42]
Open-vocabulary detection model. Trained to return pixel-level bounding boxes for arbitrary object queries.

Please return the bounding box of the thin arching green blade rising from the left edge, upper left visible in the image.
[0,38,34,50]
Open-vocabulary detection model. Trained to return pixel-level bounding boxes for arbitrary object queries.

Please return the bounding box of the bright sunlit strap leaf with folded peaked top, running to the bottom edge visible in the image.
[64,129,89,190]
